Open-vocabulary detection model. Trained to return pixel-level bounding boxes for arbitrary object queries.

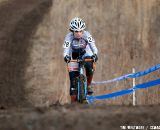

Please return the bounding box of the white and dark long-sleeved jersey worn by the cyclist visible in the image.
[63,31,98,57]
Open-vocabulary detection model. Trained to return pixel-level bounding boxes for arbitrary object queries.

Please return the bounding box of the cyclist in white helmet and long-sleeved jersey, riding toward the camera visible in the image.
[63,17,98,102]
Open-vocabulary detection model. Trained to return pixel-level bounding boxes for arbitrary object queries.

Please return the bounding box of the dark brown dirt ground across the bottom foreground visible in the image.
[0,104,160,130]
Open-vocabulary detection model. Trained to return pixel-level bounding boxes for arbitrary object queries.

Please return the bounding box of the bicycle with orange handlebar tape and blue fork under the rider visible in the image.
[68,57,93,103]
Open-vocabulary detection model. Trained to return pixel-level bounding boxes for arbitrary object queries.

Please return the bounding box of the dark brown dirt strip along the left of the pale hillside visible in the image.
[0,0,52,106]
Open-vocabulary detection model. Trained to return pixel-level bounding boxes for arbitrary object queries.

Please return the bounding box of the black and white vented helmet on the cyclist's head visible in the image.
[69,17,86,31]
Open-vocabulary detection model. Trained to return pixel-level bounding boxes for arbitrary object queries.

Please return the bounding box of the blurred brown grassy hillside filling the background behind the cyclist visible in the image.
[0,0,160,106]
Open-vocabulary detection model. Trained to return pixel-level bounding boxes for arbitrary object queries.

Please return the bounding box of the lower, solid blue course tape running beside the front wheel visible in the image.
[87,79,160,103]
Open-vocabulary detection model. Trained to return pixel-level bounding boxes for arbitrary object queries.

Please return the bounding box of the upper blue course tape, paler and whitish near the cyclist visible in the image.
[92,64,160,85]
